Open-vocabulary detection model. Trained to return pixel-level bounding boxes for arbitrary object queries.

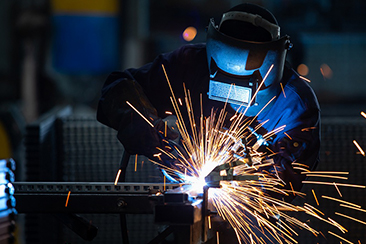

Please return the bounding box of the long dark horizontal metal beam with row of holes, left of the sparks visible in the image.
[14,182,179,214]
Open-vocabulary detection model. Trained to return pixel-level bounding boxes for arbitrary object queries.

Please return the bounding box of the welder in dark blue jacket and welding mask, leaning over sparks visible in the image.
[97,1,320,242]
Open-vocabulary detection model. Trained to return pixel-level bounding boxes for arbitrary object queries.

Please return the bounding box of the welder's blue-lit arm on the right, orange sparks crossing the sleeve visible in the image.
[258,77,320,201]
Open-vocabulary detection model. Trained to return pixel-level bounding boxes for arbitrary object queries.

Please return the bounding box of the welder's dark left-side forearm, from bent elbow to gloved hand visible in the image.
[97,76,177,158]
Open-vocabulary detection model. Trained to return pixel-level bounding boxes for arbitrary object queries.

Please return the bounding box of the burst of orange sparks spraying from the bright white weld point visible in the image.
[122,65,365,244]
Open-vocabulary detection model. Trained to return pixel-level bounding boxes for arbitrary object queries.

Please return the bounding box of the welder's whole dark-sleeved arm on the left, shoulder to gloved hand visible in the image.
[97,44,207,160]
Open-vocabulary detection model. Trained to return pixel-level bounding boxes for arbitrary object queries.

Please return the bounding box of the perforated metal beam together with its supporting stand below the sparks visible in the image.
[14,182,219,244]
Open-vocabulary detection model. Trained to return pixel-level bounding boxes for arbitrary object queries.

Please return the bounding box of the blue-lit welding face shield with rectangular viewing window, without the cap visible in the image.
[206,19,290,115]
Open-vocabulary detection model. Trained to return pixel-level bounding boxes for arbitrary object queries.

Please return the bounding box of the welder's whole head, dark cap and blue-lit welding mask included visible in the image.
[206,4,291,116]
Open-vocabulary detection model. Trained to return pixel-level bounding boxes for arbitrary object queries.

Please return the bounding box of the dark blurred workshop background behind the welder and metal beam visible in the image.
[0,0,366,244]
